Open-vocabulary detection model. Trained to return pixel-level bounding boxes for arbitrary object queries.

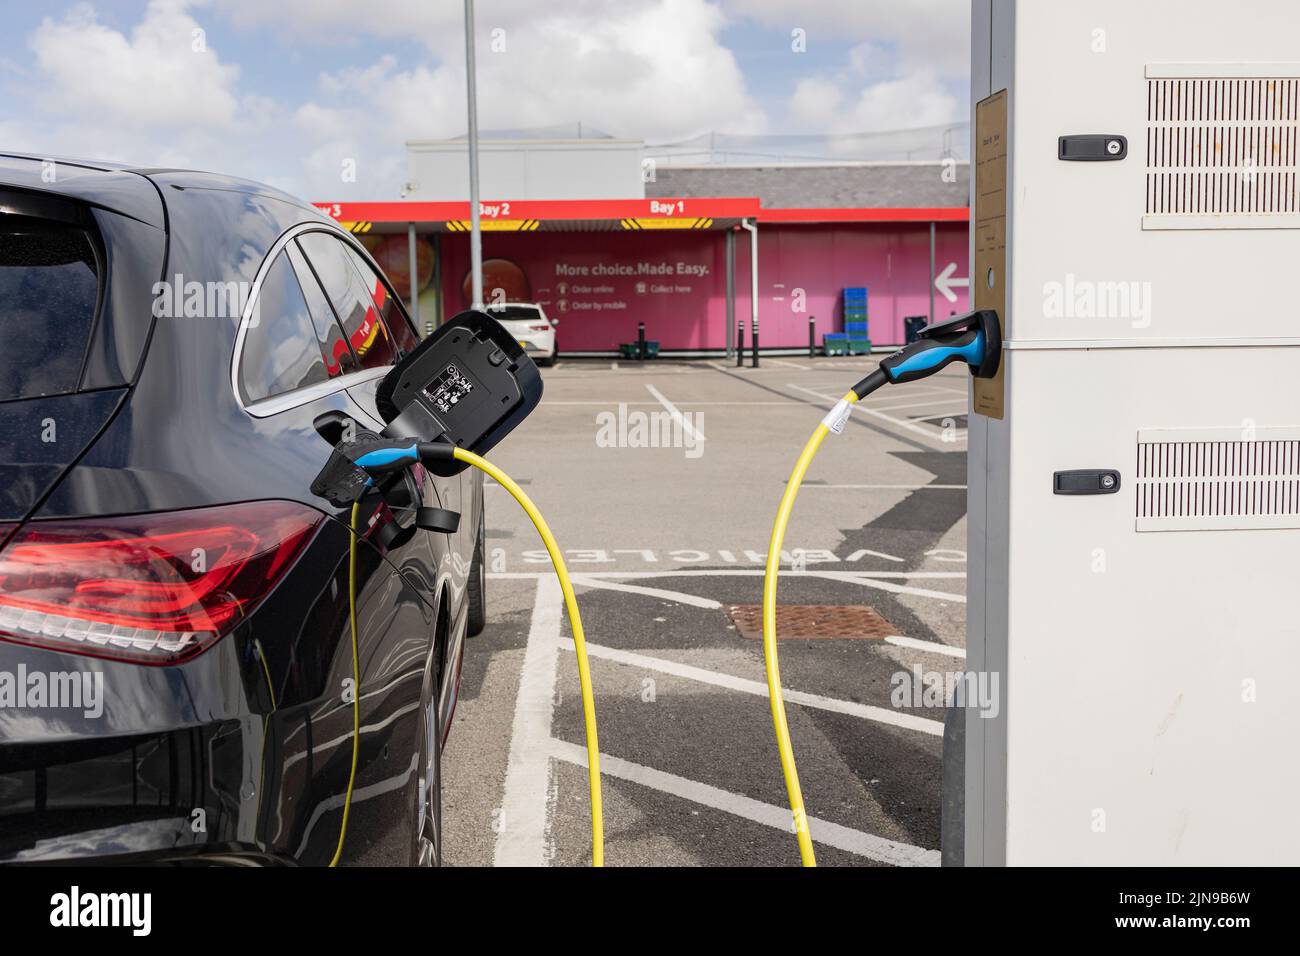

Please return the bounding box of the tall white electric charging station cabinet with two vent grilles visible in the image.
[961,0,1300,865]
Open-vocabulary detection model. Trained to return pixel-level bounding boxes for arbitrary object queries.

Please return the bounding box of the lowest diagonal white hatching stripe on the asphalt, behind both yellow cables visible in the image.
[550,739,940,866]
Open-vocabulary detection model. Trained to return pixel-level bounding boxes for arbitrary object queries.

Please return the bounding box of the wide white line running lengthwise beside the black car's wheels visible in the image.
[493,576,562,866]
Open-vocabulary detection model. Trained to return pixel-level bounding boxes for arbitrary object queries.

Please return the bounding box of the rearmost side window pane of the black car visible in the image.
[239,252,329,402]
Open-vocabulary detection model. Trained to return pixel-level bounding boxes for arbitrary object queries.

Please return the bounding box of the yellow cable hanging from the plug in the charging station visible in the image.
[763,392,858,866]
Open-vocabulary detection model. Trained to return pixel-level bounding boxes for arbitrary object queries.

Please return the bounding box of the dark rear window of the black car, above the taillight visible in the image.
[0,216,99,401]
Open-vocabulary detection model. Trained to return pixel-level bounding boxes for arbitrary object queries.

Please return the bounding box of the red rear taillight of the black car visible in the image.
[0,501,322,663]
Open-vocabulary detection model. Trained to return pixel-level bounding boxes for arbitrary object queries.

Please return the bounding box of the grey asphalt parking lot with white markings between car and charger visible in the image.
[443,358,967,866]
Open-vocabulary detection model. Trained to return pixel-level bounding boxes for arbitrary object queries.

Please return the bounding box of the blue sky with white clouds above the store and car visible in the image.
[0,0,970,200]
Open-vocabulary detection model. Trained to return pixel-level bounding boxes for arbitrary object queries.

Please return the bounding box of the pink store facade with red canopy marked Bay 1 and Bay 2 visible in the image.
[319,198,970,356]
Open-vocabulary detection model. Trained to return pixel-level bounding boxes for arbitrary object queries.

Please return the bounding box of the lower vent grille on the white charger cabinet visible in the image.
[1134,428,1300,531]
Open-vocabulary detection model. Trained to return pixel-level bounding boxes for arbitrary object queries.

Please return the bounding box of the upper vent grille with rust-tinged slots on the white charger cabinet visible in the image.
[1147,77,1300,221]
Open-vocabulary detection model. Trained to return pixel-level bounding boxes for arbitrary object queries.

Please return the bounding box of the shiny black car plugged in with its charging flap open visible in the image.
[0,156,484,865]
